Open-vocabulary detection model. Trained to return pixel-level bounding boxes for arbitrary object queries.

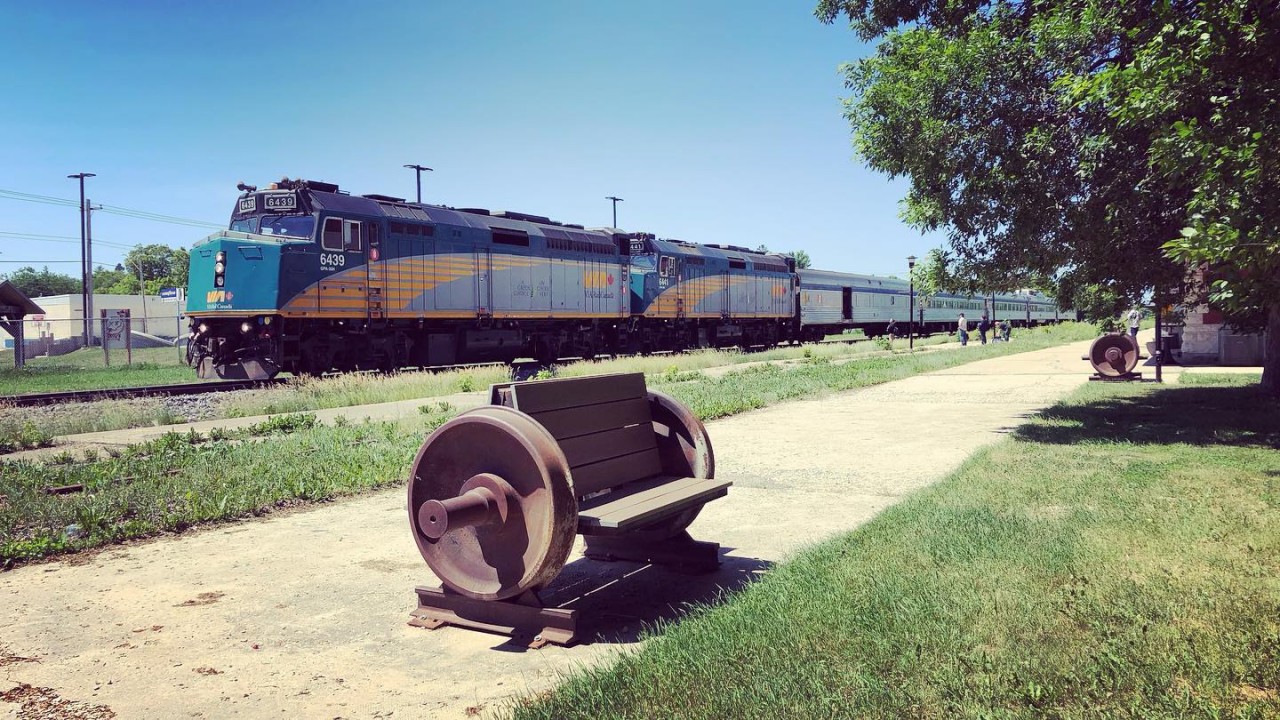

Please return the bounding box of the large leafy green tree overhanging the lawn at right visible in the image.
[817,0,1280,393]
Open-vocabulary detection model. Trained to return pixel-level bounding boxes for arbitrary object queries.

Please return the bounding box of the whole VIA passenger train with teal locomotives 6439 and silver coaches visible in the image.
[186,179,1057,379]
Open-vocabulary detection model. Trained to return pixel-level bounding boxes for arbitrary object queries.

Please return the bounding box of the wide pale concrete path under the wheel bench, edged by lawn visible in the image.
[0,333,1223,719]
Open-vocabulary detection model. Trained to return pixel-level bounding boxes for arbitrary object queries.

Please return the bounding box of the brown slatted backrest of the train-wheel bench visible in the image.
[489,373,662,497]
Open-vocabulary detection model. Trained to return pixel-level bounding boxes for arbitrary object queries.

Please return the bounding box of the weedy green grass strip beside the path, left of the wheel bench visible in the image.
[0,414,444,565]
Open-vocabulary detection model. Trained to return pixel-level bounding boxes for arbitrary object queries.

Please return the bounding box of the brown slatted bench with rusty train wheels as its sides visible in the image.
[408,373,732,644]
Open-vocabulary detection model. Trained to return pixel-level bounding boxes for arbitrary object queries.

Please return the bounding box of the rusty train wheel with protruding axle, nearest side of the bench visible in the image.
[408,406,577,600]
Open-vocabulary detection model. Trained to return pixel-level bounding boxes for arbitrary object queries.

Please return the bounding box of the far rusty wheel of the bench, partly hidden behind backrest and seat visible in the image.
[635,389,716,539]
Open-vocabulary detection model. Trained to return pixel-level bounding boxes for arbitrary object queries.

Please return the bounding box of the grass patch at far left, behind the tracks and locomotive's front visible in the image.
[0,347,196,395]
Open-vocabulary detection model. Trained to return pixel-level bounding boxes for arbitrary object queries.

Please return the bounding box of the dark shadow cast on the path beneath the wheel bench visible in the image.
[486,548,773,651]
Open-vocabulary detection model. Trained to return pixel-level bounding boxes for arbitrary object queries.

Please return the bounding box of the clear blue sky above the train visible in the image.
[0,0,941,274]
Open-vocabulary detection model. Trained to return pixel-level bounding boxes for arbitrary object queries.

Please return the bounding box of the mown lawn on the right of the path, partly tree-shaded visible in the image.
[509,383,1280,719]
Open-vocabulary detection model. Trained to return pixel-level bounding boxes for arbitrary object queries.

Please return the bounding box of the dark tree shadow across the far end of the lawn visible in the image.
[1014,387,1280,448]
